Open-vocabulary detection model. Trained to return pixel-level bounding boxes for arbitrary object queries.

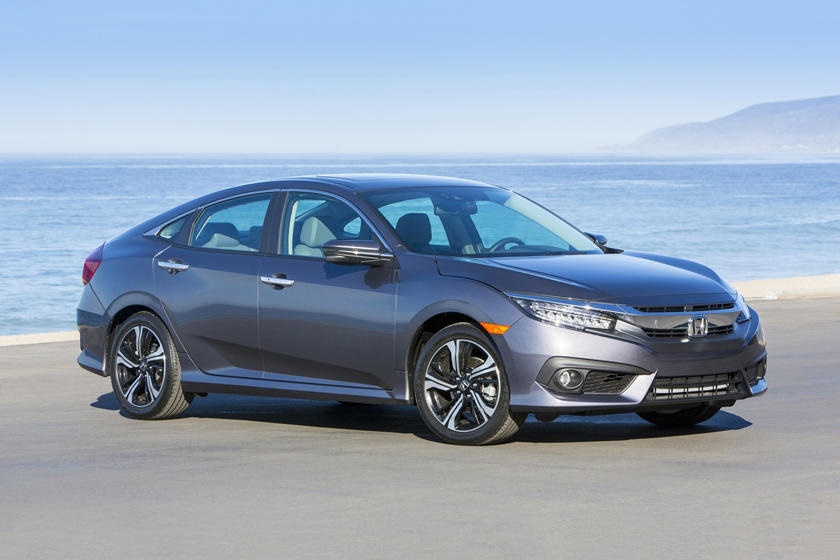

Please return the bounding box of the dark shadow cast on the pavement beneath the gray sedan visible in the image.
[91,393,752,443]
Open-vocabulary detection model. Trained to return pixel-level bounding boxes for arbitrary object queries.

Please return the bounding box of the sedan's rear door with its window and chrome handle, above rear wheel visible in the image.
[154,193,273,378]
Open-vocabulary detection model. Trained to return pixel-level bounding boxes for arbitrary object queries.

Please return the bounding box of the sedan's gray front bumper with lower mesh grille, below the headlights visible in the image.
[499,308,767,414]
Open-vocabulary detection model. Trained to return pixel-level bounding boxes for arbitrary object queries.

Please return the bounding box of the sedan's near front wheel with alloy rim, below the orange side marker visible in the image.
[413,323,527,445]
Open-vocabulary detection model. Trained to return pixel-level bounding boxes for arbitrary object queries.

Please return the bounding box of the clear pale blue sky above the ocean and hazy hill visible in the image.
[0,0,840,153]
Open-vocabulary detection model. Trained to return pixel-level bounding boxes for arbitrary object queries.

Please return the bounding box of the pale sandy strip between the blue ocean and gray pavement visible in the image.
[0,274,840,347]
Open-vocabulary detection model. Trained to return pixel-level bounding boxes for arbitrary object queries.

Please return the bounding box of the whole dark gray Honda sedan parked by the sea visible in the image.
[77,174,767,445]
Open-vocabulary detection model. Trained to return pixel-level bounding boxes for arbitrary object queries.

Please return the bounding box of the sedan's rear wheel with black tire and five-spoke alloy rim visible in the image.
[108,311,193,420]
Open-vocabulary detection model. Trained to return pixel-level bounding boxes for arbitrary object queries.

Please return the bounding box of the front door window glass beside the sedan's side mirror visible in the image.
[280,192,374,258]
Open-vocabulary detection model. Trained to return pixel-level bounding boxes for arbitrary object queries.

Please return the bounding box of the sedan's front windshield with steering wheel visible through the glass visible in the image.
[366,187,603,257]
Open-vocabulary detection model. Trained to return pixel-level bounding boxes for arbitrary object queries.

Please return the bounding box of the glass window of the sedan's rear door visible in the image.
[189,194,271,252]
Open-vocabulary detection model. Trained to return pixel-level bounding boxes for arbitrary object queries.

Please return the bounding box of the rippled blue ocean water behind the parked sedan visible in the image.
[0,155,840,335]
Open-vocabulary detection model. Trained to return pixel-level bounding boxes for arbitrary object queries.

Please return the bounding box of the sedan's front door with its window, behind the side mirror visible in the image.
[259,192,396,391]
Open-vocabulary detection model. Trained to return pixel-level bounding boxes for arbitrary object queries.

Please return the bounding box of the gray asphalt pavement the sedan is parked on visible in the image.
[0,299,840,559]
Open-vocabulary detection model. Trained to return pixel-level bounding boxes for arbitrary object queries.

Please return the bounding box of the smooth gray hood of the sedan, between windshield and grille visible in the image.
[437,252,736,306]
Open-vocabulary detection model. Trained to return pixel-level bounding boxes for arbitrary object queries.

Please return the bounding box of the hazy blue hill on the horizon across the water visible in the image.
[627,95,840,154]
